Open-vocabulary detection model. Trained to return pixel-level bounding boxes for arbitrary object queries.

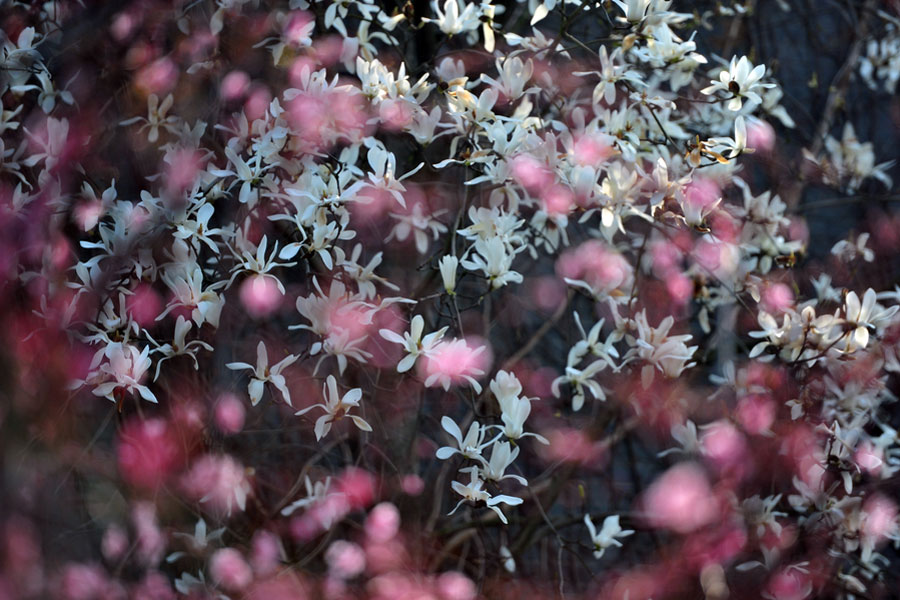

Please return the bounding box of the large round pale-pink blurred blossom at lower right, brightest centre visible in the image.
[644,463,718,534]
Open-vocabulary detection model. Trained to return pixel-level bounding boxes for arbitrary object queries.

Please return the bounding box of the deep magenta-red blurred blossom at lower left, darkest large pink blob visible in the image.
[117,419,183,490]
